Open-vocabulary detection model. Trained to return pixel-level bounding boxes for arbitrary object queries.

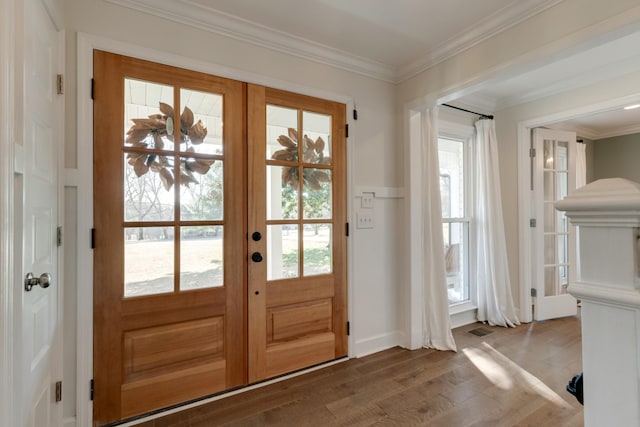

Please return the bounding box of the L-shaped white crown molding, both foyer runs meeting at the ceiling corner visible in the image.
[104,0,563,83]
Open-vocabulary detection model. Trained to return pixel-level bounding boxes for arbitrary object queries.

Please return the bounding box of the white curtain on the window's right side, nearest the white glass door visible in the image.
[474,120,520,327]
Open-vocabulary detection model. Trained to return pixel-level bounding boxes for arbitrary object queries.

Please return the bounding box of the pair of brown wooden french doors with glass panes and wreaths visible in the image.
[94,51,346,425]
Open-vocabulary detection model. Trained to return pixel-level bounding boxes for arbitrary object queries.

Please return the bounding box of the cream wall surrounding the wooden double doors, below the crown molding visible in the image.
[60,0,402,417]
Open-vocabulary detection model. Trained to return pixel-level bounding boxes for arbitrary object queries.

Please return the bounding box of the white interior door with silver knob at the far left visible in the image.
[14,0,62,427]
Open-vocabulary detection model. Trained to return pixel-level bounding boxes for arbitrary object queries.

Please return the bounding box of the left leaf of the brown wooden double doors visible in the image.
[94,51,247,425]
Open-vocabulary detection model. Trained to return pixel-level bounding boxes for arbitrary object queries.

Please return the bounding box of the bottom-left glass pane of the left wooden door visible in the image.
[124,227,174,297]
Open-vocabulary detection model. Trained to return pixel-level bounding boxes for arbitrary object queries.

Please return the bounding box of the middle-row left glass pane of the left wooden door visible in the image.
[123,153,174,221]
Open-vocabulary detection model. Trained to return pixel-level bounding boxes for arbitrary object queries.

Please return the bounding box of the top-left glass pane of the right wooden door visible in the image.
[267,105,299,162]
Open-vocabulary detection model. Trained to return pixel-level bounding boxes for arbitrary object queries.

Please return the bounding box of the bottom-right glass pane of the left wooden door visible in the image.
[180,226,224,291]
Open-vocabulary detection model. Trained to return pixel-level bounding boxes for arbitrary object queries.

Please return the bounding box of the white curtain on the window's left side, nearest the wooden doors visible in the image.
[421,107,456,351]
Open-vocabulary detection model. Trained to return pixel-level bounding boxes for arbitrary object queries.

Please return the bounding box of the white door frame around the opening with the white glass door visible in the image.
[518,92,640,322]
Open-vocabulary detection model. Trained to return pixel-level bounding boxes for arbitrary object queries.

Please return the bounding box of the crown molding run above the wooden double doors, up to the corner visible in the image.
[105,0,396,83]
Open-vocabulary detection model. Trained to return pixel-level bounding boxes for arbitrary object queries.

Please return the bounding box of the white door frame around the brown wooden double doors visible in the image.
[77,33,357,426]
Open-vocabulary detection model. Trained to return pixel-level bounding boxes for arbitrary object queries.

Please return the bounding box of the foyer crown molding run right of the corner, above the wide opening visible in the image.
[396,0,563,83]
